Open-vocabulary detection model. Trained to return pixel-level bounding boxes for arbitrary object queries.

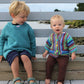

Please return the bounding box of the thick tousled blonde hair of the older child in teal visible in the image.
[9,1,30,16]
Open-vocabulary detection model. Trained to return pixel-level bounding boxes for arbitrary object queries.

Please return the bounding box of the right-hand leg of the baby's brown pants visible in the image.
[56,56,69,84]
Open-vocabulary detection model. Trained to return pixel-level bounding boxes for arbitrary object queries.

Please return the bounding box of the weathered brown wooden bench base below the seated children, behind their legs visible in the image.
[0,57,84,80]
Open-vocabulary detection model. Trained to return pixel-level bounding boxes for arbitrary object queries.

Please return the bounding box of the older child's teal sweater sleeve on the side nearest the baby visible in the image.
[28,26,36,57]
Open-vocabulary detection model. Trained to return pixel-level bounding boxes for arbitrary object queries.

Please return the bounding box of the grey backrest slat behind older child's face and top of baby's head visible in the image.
[0,12,84,21]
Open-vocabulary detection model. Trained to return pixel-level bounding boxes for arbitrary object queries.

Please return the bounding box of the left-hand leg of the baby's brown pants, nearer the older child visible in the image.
[46,56,56,79]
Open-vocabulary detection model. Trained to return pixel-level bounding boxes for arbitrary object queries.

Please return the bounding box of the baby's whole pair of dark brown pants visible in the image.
[46,56,69,83]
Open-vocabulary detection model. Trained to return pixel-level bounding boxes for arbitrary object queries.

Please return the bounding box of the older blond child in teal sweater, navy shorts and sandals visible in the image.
[0,1,36,84]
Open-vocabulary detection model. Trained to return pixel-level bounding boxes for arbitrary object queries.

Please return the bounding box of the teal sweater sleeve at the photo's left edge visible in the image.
[0,29,5,56]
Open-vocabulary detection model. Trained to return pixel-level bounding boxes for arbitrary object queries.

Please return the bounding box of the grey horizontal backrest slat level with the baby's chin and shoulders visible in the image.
[34,28,84,37]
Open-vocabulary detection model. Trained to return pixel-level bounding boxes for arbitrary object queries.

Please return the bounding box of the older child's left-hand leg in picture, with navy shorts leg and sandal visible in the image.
[6,50,21,82]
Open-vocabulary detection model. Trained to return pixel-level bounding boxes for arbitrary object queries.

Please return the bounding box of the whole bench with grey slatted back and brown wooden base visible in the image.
[0,0,84,84]
